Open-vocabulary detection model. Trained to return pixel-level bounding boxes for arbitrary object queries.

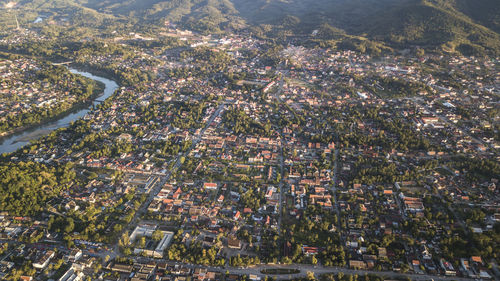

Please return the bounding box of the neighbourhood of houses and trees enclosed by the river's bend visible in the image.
[0,57,99,135]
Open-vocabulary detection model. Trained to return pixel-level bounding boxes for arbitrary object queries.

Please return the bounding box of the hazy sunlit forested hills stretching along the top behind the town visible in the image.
[3,0,500,54]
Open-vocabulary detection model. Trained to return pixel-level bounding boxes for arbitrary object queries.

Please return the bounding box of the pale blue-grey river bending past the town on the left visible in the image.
[0,68,118,154]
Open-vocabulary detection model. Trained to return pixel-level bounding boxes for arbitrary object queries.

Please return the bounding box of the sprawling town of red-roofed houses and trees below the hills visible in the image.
[0,21,500,281]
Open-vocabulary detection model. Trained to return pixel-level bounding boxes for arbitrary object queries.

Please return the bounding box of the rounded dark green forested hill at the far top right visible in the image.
[365,2,500,55]
